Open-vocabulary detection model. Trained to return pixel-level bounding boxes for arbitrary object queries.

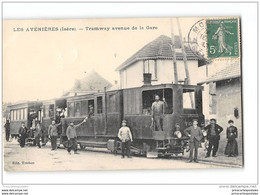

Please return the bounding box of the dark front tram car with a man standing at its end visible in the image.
[61,84,204,156]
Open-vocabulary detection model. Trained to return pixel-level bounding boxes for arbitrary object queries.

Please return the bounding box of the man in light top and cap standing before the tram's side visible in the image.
[118,120,133,158]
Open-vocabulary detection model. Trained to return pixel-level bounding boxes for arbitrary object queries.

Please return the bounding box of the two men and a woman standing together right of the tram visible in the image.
[184,119,238,162]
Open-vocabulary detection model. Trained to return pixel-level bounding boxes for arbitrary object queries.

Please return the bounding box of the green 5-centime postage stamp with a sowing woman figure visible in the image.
[206,18,240,58]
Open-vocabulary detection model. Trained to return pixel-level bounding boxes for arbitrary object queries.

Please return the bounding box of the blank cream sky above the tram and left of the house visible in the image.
[3,18,200,103]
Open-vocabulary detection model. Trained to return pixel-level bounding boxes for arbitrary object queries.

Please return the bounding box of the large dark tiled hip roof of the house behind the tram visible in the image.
[116,35,199,71]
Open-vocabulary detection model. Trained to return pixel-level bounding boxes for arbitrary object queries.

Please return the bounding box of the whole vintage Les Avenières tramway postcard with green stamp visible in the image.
[2,16,244,171]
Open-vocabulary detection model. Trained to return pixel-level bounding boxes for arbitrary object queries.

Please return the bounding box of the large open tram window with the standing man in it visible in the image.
[142,88,173,115]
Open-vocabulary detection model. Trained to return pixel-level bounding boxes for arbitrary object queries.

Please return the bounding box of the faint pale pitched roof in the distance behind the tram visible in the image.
[66,71,112,95]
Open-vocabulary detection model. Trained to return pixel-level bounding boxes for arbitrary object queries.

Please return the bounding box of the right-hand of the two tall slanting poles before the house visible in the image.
[176,18,194,108]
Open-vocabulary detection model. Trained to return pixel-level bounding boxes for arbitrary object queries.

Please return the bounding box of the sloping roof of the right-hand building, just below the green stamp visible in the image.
[203,61,241,83]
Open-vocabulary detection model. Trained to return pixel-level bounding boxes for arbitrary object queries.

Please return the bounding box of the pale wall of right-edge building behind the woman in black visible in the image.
[216,77,243,155]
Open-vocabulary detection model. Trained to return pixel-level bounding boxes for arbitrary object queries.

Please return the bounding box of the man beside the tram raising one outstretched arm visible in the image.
[66,119,86,154]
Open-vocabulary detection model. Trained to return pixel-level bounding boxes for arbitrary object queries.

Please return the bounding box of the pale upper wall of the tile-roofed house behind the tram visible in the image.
[120,60,206,88]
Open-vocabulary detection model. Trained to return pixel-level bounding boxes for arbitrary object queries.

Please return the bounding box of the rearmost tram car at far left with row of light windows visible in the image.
[8,101,42,145]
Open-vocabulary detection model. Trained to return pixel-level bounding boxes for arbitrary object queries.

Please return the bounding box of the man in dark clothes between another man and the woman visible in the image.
[204,119,223,158]
